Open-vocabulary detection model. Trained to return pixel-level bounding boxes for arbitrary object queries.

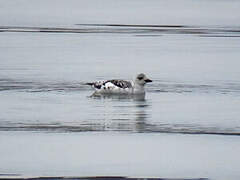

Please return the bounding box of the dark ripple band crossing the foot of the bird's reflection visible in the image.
[0,120,240,136]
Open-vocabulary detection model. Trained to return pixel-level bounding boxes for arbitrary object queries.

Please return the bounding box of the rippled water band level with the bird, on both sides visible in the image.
[0,79,240,94]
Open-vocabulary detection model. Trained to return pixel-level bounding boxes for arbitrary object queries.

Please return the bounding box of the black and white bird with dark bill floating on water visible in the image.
[86,73,152,95]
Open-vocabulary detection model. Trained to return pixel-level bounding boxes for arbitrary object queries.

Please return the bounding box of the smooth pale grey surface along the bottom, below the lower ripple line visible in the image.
[0,132,240,180]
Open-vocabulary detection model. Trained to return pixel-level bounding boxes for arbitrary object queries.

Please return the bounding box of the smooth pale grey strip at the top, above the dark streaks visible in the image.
[0,0,240,27]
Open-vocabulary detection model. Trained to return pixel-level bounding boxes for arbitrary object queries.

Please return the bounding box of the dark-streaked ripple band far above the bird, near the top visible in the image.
[0,24,240,38]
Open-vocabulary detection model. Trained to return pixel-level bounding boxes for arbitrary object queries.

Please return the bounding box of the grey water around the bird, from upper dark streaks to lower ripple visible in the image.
[0,24,240,135]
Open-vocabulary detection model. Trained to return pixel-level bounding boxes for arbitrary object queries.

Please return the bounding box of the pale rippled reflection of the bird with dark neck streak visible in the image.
[91,94,151,132]
